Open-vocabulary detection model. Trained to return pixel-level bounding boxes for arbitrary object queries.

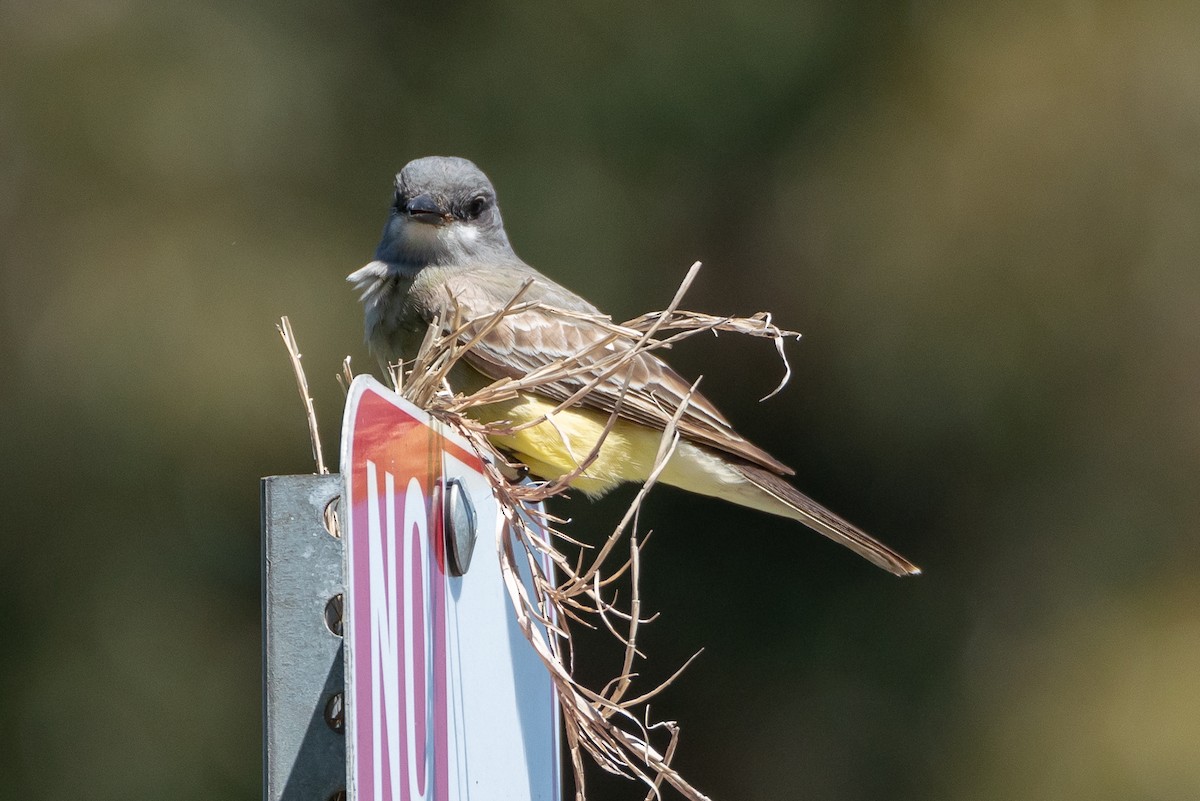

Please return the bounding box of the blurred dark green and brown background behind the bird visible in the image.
[0,0,1200,801]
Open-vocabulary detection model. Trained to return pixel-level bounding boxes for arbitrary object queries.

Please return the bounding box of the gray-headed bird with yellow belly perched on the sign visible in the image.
[347,156,920,576]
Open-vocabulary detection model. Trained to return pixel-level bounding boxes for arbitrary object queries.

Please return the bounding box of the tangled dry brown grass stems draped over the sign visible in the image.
[281,263,799,801]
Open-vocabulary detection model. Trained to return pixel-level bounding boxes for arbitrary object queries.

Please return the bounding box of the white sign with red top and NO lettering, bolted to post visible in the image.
[342,375,560,801]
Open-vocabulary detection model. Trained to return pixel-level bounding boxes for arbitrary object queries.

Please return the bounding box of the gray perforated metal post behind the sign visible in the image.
[262,474,346,801]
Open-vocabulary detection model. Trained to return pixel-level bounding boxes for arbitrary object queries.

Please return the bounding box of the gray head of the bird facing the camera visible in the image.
[376,156,515,269]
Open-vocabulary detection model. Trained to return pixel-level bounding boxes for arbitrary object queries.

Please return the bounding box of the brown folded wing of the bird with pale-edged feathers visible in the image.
[422,265,794,475]
